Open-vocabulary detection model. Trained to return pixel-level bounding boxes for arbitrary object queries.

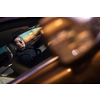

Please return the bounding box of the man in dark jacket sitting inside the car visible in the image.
[13,37,52,67]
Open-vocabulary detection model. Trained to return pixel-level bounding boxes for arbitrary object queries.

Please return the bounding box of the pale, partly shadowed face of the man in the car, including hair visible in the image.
[14,37,25,50]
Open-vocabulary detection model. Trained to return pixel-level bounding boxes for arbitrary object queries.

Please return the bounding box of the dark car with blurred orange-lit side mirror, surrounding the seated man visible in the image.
[0,17,100,84]
